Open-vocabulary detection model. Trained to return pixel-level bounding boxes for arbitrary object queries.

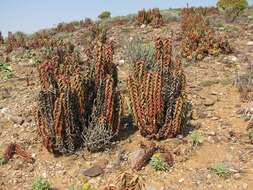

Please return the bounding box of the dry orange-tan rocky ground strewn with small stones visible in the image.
[0,8,253,190]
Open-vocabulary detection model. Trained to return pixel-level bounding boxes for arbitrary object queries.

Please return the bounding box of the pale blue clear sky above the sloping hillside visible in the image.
[0,0,253,35]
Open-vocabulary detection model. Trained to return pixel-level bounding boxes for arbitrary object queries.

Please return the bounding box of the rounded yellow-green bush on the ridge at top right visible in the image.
[217,0,248,22]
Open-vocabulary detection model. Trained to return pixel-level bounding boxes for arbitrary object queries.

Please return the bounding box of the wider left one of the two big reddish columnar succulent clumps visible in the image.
[36,41,122,154]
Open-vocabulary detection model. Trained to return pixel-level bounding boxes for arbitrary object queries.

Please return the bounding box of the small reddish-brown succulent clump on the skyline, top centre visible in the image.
[137,8,163,28]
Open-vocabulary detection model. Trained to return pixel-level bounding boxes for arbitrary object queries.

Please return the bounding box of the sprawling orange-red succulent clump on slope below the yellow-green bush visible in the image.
[181,8,232,60]
